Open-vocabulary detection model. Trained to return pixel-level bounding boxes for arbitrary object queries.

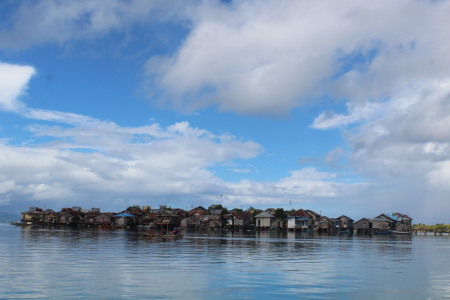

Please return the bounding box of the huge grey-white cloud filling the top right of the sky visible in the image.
[143,0,450,116]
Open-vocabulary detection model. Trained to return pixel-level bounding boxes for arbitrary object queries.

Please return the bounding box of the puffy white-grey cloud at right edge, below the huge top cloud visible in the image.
[348,81,450,174]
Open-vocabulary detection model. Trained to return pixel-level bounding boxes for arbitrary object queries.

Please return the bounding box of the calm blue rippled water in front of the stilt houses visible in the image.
[0,224,450,299]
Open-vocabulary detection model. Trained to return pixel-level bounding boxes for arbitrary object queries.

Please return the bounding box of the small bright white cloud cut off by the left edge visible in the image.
[0,62,35,111]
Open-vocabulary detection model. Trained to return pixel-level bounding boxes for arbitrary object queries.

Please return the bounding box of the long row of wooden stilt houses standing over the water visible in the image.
[14,204,412,234]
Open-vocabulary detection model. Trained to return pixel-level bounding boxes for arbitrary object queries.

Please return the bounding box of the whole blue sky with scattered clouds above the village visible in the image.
[0,0,450,224]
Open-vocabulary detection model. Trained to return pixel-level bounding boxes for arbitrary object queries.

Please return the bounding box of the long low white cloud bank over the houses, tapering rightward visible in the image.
[0,116,361,209]
